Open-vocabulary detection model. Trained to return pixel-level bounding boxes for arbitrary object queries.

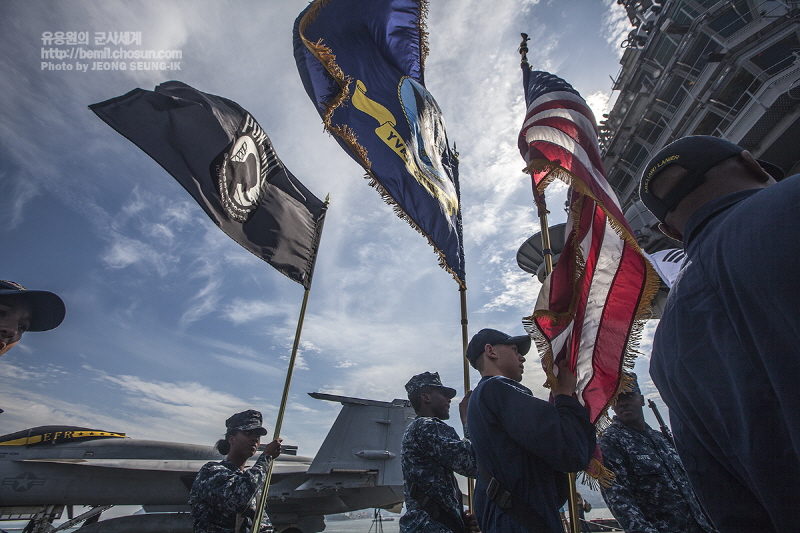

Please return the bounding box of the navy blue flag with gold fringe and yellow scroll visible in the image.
[294,0,465,287]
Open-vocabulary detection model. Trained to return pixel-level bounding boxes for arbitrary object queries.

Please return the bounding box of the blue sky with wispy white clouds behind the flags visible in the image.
[0,0,656,482]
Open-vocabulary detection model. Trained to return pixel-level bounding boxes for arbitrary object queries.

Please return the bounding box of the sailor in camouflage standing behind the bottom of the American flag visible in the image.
[600,372,716,533]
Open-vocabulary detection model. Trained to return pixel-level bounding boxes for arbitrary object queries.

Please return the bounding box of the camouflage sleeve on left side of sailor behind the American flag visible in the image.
[600,438,660,533]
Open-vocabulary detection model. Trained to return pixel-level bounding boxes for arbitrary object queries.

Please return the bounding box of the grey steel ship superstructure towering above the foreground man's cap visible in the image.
[600,0,800,253]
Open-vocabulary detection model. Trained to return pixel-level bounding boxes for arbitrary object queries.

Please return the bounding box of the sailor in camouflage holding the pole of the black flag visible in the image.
[189,409,281,533]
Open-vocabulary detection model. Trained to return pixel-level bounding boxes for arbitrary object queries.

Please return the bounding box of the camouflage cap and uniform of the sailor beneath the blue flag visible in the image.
[400,372,477,533]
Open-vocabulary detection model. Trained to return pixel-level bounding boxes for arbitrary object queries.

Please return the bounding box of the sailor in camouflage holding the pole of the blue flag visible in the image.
[400,372,477,533]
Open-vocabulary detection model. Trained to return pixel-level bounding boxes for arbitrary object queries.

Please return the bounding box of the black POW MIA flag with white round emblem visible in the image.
[89,81,327,289]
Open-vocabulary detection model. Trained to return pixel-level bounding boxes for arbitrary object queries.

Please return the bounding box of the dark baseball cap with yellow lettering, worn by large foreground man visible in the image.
[639,135,785,222]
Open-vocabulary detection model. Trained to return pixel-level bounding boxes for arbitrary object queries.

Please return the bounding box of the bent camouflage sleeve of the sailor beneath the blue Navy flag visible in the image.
[417,418,478,478]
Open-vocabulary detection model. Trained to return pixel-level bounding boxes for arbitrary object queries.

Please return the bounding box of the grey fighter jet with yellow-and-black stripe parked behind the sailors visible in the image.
[0,393,414,533]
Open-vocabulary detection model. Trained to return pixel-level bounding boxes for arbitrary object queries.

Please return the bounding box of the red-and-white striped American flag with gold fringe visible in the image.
[519,68,659,440]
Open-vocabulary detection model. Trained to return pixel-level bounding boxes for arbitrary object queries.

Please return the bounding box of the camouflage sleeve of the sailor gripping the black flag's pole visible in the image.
[203,454,272,513]
